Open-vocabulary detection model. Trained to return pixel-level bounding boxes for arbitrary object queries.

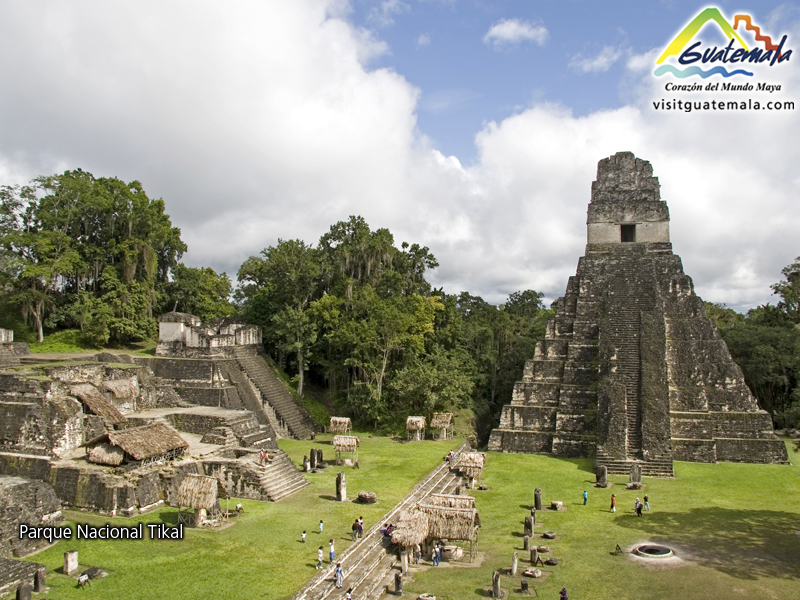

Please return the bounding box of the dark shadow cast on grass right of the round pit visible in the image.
[615,507,800,580]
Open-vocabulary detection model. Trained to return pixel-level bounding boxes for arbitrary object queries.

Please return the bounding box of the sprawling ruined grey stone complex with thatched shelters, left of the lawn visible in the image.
[0,313,314,560]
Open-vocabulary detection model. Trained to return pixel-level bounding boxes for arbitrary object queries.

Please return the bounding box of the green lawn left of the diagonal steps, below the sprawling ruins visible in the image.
[29,434,461,600]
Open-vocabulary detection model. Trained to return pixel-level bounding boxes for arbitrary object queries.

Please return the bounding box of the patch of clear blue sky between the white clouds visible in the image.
[349,0,789,164]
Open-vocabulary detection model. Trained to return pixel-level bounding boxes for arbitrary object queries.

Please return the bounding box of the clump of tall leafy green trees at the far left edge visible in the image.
[0,169,186,341]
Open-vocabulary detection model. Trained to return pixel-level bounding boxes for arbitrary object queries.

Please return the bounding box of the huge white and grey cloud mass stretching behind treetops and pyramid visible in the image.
[0,0,800,308]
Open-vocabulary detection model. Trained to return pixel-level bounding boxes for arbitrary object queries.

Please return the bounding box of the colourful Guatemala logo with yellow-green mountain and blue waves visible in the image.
[654,8,792,79]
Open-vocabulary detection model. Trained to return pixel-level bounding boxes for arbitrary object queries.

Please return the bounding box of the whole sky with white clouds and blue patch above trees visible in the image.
[0,0,800,310]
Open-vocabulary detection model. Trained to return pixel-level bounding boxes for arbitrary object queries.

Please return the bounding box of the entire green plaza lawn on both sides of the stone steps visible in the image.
[21,434,800,600]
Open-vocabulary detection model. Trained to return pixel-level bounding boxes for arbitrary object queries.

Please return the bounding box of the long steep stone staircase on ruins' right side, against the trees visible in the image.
[234,348,314,440]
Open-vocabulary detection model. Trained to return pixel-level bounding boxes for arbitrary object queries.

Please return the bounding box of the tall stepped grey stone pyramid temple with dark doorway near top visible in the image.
[489,152,788,476]
